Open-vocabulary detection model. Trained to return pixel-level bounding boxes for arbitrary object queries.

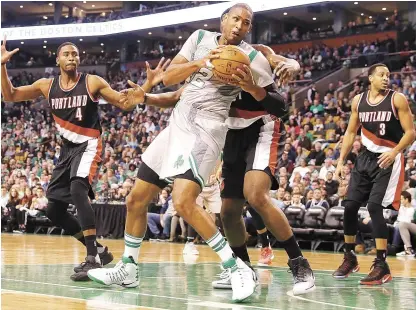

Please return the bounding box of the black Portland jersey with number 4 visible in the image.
[48,73,101,143]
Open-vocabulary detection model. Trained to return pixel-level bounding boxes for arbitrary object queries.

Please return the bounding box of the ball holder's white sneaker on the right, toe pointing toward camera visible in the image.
[222,257,256,302]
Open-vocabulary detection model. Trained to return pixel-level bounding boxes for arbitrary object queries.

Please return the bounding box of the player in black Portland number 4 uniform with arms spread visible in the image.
[1,39,169,281]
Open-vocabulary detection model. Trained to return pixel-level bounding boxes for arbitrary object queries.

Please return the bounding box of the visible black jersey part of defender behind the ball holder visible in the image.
[227,91,269,129]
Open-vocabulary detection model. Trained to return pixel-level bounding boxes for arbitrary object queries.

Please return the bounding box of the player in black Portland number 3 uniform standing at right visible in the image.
[333,64,415,285]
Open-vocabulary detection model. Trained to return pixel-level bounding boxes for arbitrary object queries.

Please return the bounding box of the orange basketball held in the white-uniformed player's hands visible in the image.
[211,45,250,84]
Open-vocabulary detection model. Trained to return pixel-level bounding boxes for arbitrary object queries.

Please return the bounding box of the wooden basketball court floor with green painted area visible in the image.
[1,234,416,310]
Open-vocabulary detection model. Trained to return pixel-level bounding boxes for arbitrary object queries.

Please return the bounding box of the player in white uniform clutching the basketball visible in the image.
[88,4,282,302]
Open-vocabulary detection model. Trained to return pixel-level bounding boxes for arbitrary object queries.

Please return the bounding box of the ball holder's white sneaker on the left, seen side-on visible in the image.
[88,256,139,287]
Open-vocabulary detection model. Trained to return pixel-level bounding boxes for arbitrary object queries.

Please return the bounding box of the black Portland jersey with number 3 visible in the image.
[357,89,404,153]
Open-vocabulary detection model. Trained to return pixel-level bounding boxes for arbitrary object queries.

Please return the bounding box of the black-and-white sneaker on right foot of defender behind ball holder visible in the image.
[287,256,316,295]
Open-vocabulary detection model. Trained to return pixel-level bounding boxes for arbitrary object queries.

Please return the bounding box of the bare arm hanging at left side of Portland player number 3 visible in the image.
[335,95,360,179]
